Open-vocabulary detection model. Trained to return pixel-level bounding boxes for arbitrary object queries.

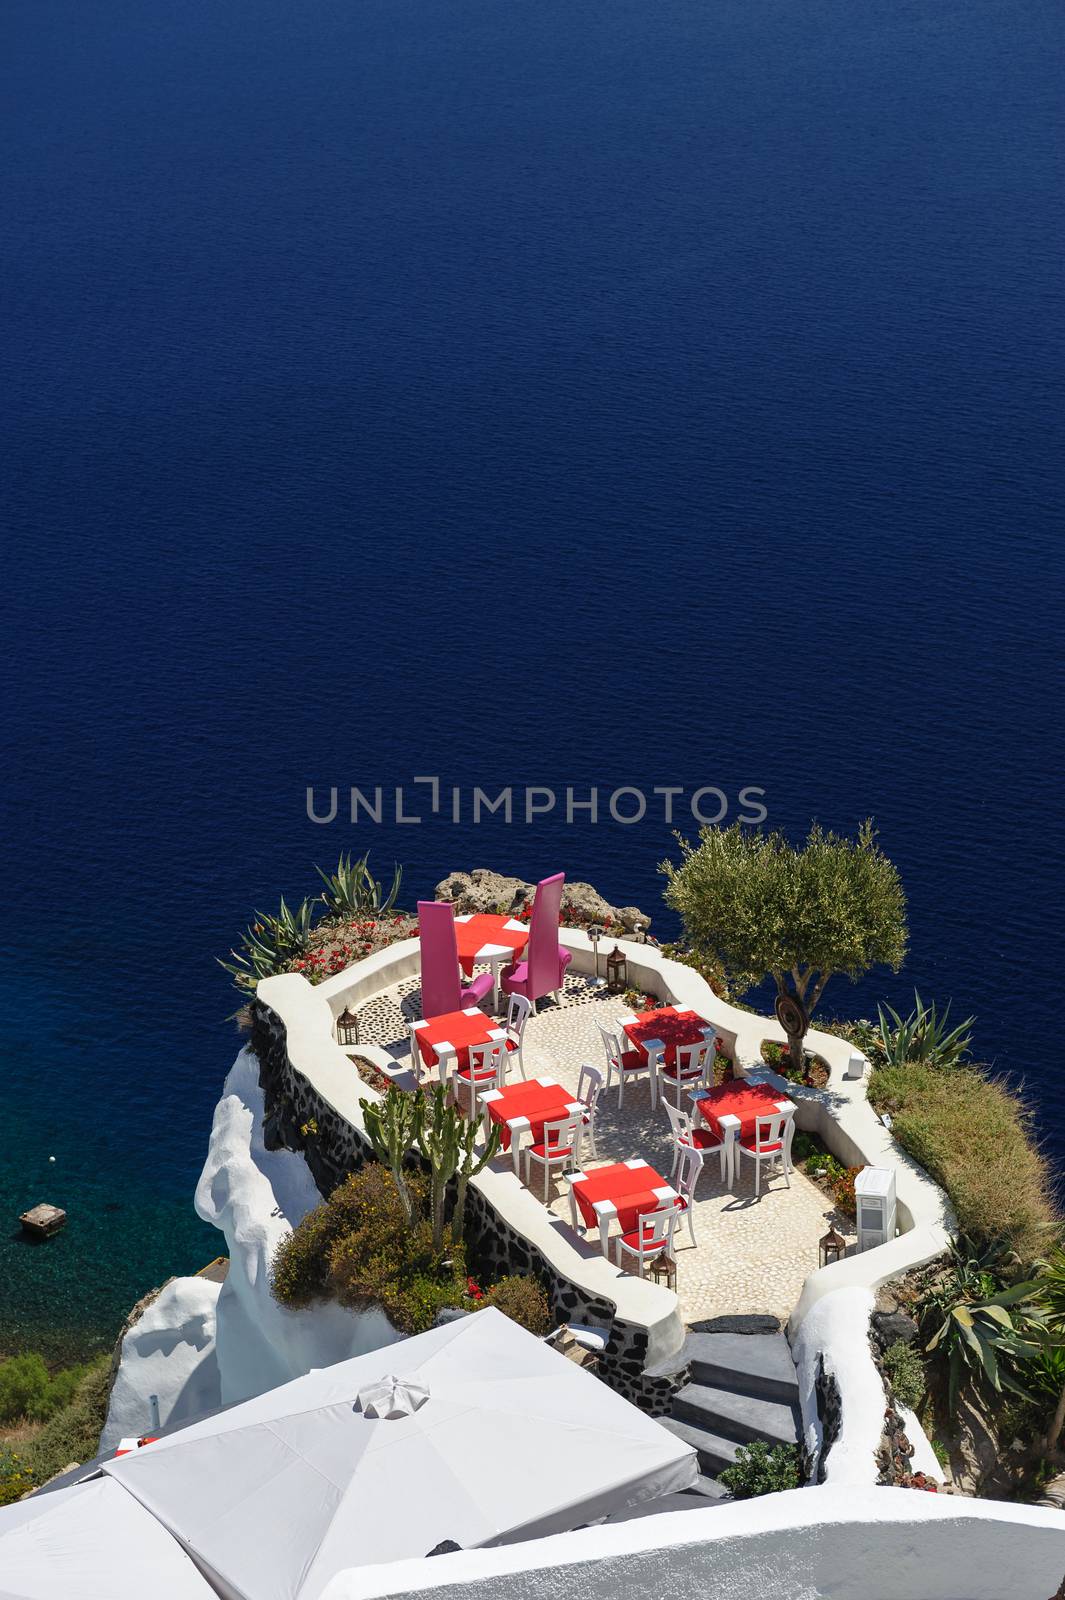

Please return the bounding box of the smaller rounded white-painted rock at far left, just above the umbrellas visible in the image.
[99,1278,222,1451]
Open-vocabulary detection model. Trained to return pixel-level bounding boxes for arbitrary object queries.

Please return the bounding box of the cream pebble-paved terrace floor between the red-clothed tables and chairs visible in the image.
[358,978,852,1323]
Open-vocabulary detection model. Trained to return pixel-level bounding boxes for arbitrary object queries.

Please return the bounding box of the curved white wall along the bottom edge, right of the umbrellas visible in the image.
[323,1486,1065,1600]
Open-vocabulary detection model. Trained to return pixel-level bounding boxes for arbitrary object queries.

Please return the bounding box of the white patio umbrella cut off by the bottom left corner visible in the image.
[0,1478,216,1600]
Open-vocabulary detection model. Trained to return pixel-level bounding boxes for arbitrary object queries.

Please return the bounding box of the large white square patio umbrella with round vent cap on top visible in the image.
[104,1309,697,1600]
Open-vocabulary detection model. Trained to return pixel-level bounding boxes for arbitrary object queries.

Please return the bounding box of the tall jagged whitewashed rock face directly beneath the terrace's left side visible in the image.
[195,1050,400,1405]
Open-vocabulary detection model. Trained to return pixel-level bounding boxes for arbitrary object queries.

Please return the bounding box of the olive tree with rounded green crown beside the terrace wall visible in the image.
[660,821,907,1070]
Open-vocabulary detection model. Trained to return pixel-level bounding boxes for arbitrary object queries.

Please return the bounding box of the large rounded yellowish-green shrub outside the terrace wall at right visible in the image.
[868,1061,1060,1262]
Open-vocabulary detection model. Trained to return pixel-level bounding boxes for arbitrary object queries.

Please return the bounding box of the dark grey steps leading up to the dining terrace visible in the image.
[659,1333,801,1502]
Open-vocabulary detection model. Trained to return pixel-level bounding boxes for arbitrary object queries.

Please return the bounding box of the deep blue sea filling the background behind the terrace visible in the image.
[0,0,1065,1349]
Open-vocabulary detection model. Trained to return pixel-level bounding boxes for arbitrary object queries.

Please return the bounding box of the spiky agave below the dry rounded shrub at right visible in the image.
[919,1242,1047,1411]
